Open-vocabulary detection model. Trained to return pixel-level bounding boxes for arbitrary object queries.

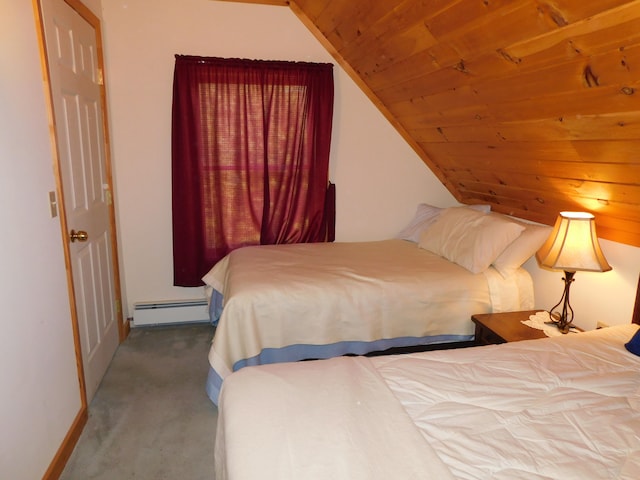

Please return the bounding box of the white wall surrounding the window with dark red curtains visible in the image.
[103,0,455,315]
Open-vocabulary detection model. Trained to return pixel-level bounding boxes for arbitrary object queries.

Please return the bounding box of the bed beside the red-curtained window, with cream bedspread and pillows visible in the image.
[204,207,547,404]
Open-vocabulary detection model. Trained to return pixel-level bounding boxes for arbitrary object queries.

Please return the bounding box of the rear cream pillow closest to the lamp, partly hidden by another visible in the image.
[491,213,553,278]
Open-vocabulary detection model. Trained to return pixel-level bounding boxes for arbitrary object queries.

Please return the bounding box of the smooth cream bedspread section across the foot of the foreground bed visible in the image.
[215,357,453,480]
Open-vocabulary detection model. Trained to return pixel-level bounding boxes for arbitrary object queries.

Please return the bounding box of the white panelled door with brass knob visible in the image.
[41,0,118,402]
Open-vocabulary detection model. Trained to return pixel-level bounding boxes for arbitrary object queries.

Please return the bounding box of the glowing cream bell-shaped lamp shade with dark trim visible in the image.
[536,212,611,272]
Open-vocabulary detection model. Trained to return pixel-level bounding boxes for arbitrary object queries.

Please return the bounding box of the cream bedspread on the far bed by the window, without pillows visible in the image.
[205,240,533,378]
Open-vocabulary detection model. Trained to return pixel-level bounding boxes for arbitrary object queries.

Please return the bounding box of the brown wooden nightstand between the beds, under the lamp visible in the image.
[471,310,547,345]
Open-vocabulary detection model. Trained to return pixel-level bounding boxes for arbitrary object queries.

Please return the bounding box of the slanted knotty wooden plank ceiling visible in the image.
[219,0,640,251]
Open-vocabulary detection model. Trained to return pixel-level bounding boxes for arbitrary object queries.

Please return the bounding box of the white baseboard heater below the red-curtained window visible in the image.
[133,299,209,327]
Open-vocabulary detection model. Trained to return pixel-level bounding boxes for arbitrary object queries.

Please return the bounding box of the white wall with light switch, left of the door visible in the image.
[0,0,81,480]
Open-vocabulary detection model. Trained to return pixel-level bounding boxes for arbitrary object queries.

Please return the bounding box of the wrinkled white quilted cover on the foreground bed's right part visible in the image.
[372,325,640,480]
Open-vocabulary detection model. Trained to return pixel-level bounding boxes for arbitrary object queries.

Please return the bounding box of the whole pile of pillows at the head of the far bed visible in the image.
[397,204,552,278]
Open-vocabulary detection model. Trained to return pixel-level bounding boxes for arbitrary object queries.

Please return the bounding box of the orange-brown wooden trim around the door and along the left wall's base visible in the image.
[32,0,129,479]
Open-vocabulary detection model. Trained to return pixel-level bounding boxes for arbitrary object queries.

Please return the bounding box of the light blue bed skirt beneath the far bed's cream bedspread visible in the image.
[206,335,473,405]
